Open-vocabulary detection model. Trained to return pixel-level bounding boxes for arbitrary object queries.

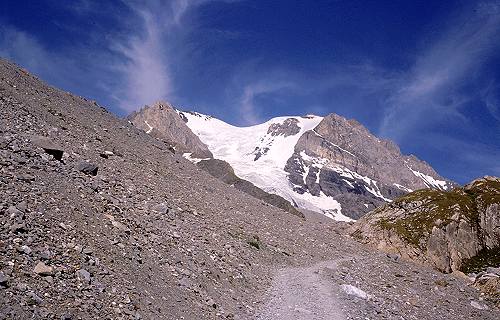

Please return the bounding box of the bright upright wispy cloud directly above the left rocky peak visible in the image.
[104,0,204,112]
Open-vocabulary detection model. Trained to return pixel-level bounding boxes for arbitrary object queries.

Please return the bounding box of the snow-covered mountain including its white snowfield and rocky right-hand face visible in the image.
[127,102,454,221]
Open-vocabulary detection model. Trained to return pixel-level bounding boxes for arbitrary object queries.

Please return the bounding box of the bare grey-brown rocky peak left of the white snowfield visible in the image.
[127,102,212,158]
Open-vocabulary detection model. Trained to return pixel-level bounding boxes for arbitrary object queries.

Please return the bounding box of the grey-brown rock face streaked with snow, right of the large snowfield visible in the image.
[285,114,455,219]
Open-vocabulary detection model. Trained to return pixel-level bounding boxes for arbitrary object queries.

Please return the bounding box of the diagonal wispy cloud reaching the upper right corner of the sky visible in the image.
[380,2,500,140]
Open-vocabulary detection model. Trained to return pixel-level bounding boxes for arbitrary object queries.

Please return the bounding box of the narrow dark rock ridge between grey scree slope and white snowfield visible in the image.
[197,159,304,217]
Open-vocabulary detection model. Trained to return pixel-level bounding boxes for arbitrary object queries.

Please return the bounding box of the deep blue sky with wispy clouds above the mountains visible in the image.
[0,0,500,183]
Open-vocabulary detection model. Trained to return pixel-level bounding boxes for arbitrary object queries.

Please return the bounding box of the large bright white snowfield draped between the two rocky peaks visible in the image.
[183,112,353,221]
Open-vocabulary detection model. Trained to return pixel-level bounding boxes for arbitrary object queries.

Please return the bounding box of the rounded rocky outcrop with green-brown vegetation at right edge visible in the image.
[351,177,500,273]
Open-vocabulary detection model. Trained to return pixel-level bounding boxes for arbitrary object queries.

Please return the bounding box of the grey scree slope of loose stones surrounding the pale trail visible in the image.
[0,59,500,319]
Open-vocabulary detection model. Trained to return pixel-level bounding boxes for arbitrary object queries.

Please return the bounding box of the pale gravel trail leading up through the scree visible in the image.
[257,260,347,320]
